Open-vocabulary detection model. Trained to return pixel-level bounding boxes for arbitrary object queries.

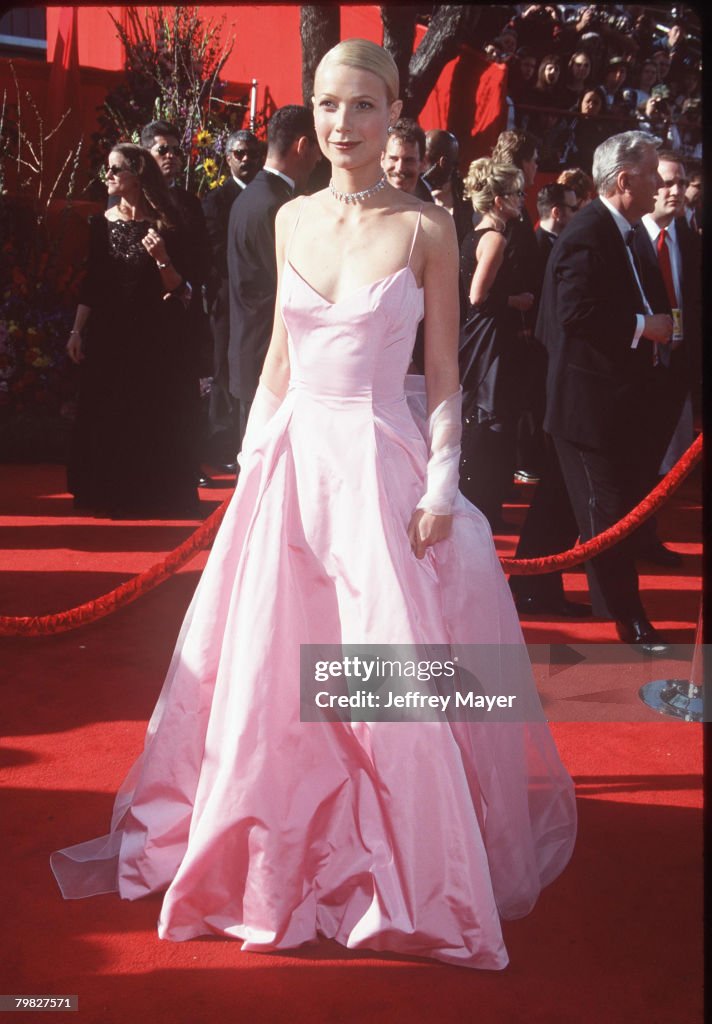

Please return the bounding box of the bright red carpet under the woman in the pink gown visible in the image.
[0,466,702,1024]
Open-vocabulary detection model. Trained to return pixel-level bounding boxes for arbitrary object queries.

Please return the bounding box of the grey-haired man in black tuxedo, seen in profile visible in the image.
[537,131,672,653]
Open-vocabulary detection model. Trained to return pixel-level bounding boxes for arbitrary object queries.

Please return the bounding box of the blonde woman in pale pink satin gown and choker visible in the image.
[52,40,576,969]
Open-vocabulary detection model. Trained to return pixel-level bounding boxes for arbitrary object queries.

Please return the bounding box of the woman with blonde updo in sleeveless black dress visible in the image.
[459,159,534,530]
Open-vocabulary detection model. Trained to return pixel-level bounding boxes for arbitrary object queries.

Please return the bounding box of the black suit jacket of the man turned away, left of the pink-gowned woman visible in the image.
[227,170,293,401]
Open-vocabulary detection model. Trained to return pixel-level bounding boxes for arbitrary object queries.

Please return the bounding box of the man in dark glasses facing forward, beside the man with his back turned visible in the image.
[203,129,262,471]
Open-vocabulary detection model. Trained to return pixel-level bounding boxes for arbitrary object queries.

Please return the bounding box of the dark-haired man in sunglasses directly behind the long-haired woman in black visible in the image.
[140,121,212,487]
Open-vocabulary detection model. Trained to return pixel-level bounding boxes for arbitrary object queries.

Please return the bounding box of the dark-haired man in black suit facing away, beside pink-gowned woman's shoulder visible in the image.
[227,104,321,440]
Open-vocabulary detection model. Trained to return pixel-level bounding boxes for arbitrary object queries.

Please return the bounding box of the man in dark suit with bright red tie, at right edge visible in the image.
[633,152,702,567]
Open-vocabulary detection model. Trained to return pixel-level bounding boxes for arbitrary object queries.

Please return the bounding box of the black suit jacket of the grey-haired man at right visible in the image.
[537,200,653,451]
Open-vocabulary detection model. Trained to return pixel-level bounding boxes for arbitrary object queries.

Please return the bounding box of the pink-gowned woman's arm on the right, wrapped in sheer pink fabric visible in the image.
[408,206,461,558]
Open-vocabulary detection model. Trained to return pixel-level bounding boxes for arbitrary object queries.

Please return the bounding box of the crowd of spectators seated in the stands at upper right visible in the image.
[485,4,702,174]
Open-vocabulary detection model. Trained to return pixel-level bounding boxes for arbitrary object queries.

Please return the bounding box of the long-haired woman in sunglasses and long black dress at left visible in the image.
[67,143,199,517]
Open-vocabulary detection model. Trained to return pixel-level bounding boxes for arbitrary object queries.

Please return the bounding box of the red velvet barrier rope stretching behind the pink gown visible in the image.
[0,434,702,637]
